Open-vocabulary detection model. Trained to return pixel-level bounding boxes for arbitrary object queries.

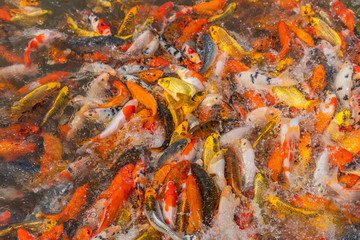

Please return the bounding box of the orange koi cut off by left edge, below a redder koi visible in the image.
[0,140,35,161]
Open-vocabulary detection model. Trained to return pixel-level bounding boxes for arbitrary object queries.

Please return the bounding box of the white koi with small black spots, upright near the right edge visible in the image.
[334,62,354,110]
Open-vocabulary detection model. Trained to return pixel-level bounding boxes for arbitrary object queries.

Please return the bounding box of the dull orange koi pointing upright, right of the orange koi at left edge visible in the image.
[39,132,64,179]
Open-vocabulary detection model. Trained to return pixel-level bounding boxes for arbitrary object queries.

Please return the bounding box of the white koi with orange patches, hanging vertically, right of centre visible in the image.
[280,118,300,185]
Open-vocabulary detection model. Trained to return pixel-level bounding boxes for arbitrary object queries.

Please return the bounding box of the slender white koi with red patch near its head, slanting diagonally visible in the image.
[76,99,138,154]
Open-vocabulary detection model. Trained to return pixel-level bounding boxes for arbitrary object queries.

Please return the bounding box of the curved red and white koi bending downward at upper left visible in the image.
[24,30,65,68]
